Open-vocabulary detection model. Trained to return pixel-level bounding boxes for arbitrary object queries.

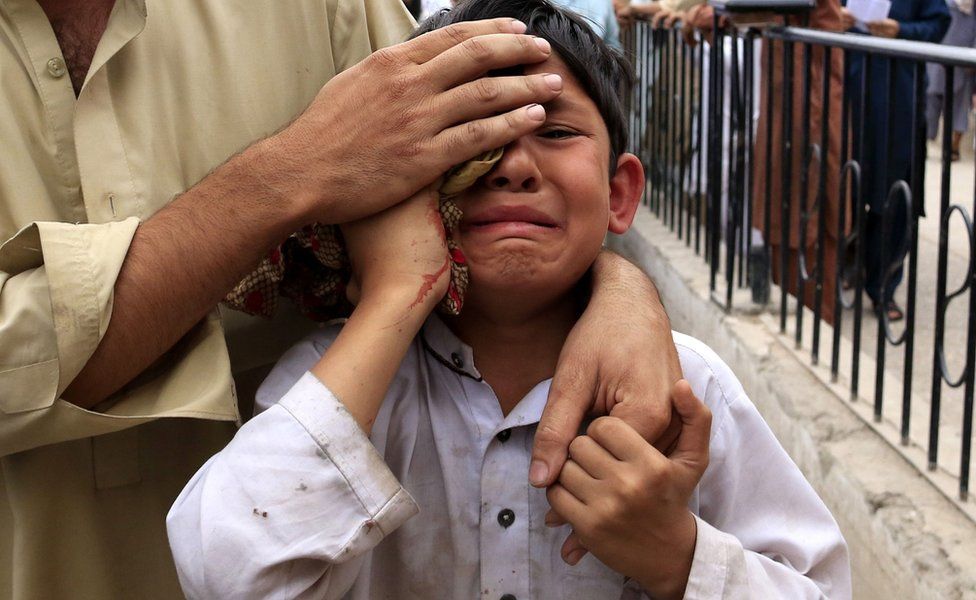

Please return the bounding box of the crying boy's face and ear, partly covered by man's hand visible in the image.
[456,53,644,308]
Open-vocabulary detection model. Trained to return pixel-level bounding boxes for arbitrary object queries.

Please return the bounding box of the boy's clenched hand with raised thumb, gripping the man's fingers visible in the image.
[546,380,712,598]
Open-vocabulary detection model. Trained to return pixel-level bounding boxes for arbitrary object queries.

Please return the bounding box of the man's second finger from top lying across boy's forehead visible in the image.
[422,33,552,90]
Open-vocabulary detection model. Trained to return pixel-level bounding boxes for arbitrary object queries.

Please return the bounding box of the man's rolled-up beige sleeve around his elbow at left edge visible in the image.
[0,218,238,456]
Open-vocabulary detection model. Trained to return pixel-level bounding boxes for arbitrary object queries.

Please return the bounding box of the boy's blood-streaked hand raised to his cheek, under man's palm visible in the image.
[342,186,450,310]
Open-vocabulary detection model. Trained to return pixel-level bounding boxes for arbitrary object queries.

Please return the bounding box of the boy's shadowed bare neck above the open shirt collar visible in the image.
[446,284,582,415]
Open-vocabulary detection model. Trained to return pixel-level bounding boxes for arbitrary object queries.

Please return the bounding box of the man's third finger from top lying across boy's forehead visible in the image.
[434,73,563,125]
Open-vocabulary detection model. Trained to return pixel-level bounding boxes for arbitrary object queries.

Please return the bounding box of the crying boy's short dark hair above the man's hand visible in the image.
[411,0,633,174]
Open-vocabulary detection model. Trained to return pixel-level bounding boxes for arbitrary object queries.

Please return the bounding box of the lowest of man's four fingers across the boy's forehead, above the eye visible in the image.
[434,104,546,169]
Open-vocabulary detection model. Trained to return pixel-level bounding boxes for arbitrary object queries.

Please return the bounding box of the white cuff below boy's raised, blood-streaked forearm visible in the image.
[278,373,419,555]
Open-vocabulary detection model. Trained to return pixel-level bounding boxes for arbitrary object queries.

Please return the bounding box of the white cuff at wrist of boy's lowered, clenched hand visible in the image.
[684,515,748,600]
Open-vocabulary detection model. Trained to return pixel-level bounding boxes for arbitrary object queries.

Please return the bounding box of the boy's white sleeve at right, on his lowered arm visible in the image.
[685,396,851,600]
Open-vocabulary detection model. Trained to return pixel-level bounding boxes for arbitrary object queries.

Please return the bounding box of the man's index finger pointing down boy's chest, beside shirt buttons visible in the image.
[529,358,596,487]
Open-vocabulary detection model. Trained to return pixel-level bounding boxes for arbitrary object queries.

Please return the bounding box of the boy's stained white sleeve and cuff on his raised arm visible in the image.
[166,374,418,598]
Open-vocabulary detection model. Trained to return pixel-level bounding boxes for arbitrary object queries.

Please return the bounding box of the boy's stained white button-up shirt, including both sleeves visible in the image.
[167,317,851,600]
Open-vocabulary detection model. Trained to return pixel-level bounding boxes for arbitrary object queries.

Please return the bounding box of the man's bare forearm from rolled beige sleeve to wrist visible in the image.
[63,141,306,408]
